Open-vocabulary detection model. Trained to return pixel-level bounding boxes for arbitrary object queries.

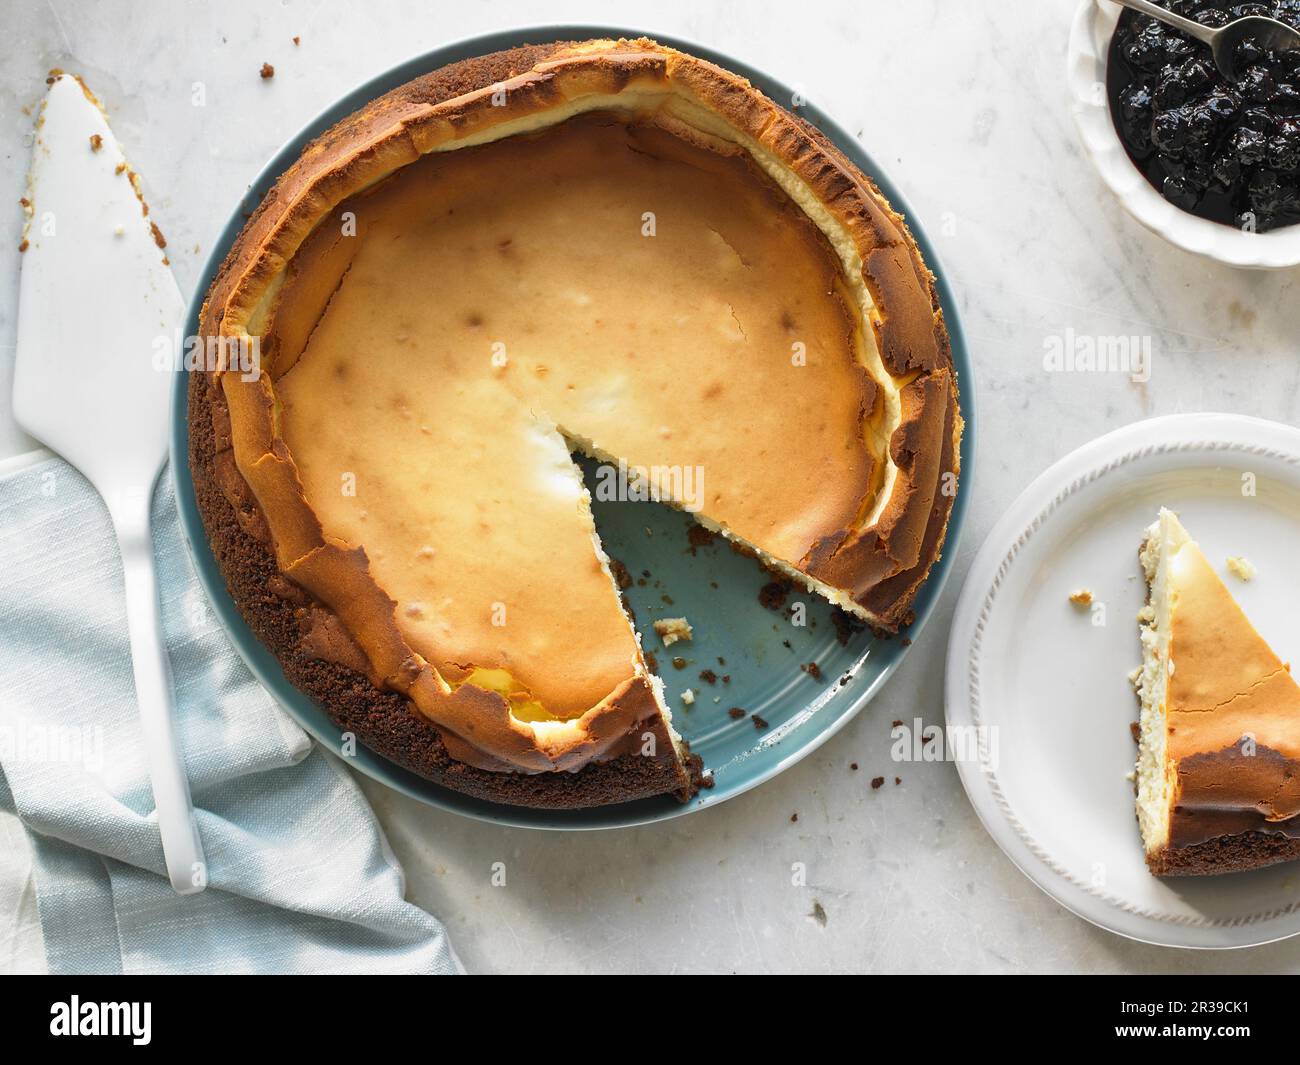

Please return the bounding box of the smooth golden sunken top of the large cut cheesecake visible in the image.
[272,116,881,718]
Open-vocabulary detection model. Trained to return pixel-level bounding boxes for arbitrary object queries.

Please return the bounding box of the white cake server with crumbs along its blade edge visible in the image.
[13,74,207,895]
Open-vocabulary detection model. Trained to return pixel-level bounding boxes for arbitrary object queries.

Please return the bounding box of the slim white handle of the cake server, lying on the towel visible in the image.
[109,492,208,895]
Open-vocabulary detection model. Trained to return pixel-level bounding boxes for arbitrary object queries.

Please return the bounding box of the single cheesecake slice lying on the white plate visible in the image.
[1135,508,1300,876]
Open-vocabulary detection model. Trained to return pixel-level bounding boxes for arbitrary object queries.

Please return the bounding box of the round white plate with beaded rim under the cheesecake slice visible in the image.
[945,414,1300,947]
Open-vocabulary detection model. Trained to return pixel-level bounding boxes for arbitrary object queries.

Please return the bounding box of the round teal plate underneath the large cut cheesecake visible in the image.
[172,26,975,828]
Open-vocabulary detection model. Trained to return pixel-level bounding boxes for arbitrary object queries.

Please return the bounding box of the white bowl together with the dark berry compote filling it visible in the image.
[1070,0,1300,268]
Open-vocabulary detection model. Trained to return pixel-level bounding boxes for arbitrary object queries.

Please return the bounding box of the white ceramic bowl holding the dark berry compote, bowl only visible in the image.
[1067,0,1300,269]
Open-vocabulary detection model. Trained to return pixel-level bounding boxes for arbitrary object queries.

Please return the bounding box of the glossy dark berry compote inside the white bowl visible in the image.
[1106,0,1300,233]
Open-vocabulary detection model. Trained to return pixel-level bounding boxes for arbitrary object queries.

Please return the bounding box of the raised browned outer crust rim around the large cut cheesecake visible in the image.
[190,40,962,806]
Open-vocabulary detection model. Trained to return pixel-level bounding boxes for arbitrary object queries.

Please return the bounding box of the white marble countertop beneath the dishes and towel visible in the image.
[0,0,1300,973]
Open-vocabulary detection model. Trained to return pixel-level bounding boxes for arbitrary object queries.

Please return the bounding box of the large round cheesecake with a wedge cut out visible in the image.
[189,39,962,808]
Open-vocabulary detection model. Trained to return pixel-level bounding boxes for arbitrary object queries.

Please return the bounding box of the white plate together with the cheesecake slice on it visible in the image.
[932,414,1300,947]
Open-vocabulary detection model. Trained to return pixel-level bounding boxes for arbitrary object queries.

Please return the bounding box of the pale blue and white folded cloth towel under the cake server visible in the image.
[0,458,460,973]
